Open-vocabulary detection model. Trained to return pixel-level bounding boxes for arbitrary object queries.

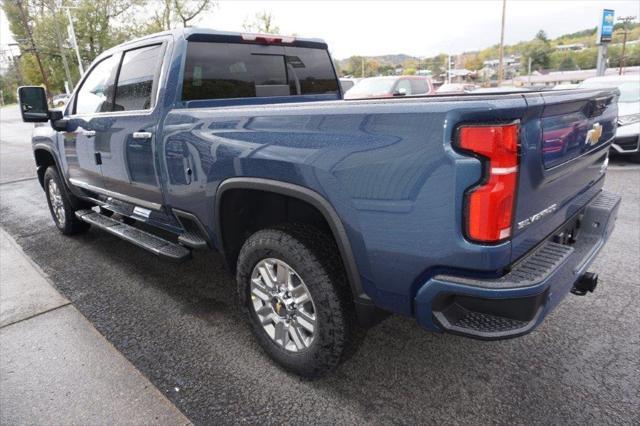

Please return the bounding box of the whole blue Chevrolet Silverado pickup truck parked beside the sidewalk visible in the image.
[19,29,620,377]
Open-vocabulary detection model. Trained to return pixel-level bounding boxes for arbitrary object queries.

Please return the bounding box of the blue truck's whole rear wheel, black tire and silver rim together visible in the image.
[237,226,354,377]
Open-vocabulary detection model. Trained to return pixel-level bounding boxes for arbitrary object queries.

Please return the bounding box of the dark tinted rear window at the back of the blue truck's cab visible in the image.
[182,42,338,101]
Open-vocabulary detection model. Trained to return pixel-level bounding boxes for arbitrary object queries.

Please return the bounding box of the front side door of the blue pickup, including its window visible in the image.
[62,55,120,192]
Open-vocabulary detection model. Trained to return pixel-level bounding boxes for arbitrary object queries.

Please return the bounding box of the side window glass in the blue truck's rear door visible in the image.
[113,45,162,111]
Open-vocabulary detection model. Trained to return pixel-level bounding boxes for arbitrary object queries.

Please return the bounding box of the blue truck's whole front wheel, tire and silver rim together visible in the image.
[44,166,89,235]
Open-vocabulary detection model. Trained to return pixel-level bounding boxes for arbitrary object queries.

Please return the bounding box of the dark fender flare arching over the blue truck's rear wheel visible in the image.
[215,177,373,305]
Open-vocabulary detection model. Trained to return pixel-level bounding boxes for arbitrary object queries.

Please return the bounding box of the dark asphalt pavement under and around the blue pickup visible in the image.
[0,104,640,424]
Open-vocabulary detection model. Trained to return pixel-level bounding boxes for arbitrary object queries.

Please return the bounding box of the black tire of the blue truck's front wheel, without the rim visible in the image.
[44,166,89,235]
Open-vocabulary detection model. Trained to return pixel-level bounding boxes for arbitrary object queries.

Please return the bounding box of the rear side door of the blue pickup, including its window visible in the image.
[96,43,165,210]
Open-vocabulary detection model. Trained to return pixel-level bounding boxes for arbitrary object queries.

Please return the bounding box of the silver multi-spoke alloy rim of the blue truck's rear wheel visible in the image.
[251,258,316,352]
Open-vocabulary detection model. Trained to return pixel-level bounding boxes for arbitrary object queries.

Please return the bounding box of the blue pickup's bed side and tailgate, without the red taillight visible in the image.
[160,90,616,314]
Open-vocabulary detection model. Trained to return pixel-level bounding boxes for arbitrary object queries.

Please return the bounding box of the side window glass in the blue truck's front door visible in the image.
[75,56,117,114]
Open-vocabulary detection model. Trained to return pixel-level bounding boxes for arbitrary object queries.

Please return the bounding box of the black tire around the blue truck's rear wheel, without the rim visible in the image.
[236,225,356,378]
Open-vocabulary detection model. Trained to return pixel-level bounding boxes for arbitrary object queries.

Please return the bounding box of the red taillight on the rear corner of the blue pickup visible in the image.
[458,124,518,243]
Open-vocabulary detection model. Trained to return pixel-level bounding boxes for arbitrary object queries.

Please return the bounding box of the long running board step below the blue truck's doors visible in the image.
[76,210,191,262]
